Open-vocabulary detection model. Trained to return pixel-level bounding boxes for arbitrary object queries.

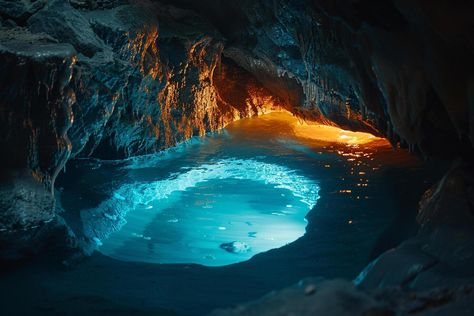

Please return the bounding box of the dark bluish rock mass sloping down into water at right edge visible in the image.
[357,162,474,288]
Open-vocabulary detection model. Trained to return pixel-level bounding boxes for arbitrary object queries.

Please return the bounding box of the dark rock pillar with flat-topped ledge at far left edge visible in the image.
[0,28,75,260]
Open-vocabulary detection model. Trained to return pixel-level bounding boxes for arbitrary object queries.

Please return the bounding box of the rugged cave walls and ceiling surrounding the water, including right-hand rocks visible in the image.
[0,0,474,315]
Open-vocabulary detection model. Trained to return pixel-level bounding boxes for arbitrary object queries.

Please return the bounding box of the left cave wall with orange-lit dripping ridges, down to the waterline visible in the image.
[0,0,279,258]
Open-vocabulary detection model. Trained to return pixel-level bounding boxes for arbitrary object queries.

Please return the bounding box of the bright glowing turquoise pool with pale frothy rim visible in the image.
[83,157,319,266]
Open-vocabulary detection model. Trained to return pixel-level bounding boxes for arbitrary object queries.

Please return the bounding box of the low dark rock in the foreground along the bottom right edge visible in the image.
[209,279,474,316]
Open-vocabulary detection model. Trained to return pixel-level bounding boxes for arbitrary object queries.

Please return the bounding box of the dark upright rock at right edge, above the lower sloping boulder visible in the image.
[417,161,474,268]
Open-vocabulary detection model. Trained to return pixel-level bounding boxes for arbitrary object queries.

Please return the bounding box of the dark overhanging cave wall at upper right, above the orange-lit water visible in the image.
[161,0,474,158]
